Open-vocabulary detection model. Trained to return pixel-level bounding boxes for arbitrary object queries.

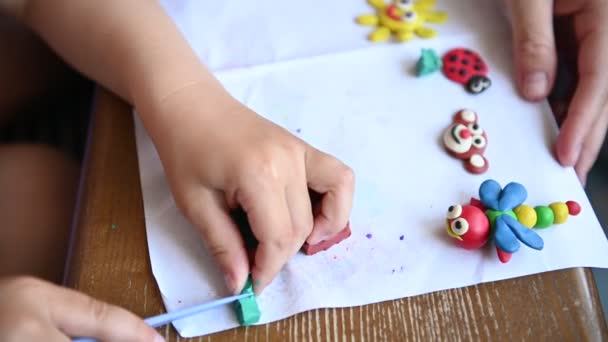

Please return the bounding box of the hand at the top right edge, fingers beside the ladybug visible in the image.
[506,0,608,183]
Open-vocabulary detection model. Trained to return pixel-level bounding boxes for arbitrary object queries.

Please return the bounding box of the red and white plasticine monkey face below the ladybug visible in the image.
[443,109,490,174]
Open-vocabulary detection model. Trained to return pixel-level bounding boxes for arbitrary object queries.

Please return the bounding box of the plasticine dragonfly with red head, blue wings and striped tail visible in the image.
[446,179,581,263]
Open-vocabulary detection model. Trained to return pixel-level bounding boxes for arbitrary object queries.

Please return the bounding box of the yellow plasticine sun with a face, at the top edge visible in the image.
[357,0,448,42]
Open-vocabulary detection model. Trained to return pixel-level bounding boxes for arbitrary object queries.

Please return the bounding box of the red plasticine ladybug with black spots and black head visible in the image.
[442,48,492,94]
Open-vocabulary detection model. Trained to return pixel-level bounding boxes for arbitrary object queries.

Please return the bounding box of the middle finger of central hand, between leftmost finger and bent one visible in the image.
[239,181,299,294]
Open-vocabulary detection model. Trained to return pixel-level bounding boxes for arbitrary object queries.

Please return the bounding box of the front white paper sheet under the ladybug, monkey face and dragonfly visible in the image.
[136,1,608,337]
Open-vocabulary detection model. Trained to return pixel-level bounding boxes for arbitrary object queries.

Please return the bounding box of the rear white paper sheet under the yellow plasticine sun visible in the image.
[161,0,504,70]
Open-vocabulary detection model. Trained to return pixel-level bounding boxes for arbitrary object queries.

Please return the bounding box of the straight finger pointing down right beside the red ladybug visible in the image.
[507,0,557,100]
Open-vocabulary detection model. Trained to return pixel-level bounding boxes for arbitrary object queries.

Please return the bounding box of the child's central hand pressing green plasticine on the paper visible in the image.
[149,85,354,293]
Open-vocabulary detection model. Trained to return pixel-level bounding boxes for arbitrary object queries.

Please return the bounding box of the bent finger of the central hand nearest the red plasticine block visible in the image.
[306,150,355,244]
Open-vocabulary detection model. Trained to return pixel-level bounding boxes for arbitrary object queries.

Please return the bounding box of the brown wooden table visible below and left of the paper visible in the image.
[67,90,608,341]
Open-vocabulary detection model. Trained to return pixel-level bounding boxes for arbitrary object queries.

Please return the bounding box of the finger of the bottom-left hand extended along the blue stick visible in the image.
[44,285,164,342]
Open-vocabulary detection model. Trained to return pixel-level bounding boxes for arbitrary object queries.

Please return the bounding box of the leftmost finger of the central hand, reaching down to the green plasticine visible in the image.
[188,189,249,293]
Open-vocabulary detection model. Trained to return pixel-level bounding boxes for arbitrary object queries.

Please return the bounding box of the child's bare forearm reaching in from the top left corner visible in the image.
[0,0,224,123]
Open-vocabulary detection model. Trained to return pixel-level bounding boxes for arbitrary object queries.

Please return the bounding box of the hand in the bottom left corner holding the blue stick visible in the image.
[0,278,164,342]
